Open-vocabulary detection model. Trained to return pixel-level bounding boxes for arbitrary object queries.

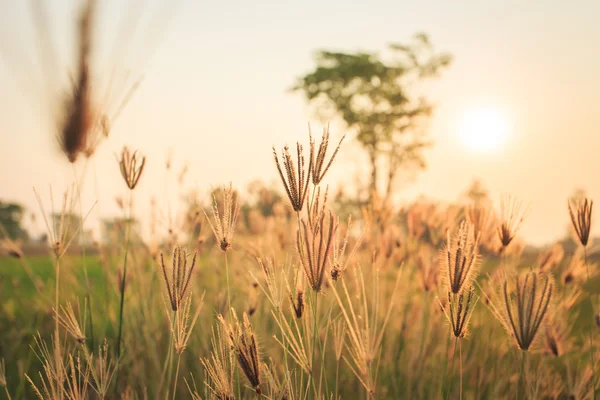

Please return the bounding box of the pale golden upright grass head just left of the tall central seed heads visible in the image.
[202,182,240,251]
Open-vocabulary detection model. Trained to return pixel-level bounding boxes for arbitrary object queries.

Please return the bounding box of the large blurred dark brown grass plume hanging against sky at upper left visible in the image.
[58,0,96,163]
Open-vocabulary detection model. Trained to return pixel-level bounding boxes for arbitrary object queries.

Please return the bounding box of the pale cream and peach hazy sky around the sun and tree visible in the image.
[0,0,600,245]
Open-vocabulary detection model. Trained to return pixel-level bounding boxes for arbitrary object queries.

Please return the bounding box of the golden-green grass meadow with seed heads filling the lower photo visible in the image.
[0,126,600,399]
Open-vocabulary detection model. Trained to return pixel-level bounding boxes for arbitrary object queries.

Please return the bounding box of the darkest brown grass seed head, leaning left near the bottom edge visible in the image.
[218,309,262,395]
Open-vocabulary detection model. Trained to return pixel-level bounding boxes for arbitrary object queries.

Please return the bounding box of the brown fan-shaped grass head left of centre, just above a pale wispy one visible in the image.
[160,246,198,311]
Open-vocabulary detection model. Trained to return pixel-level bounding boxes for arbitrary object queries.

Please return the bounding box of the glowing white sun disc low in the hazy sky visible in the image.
[459,107,511,153]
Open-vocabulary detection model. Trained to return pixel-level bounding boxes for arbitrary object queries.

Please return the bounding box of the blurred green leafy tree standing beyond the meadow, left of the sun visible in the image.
[292,33,451,200]
